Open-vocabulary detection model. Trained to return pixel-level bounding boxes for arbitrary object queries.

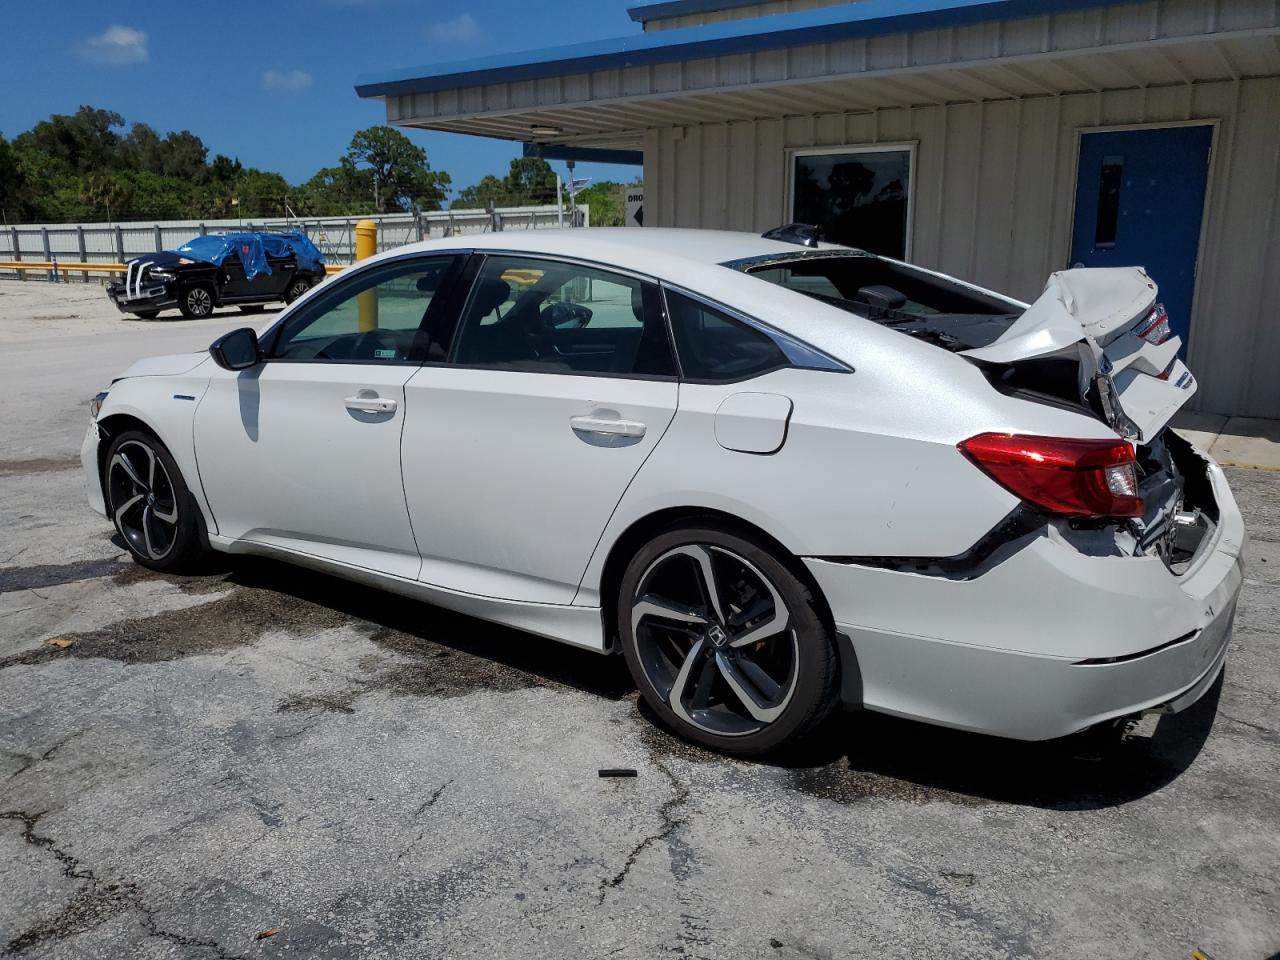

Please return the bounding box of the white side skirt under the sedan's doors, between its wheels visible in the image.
[209,536,611,653]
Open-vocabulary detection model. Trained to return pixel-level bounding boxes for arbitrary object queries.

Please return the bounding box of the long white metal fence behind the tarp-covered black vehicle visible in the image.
[0,205,590,279]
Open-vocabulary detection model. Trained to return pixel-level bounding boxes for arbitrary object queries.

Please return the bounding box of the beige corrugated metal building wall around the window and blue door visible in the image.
[644,78,1280,417]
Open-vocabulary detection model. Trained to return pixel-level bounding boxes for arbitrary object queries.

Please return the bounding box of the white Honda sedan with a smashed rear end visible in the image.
[82,225,1245,754]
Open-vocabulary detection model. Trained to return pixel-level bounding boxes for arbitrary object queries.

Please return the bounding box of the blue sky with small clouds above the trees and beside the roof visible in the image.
[0,0,640,197]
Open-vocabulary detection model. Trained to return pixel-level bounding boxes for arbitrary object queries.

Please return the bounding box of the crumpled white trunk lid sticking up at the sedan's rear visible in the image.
[963,266,1196,443]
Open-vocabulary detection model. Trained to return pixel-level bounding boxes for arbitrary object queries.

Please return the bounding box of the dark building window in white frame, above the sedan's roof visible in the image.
[791,147,911,260]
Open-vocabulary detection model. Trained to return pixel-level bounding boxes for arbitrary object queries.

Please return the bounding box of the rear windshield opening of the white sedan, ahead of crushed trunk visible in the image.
[726,253,1025,351]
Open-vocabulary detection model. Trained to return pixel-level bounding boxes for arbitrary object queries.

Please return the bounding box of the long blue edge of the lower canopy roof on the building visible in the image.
[356,0,1117,99]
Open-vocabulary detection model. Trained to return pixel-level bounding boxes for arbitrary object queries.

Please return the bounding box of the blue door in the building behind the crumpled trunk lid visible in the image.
[1071,125,1213,358]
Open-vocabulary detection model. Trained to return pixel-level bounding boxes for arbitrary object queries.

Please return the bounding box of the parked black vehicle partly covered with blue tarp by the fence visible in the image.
[106,233,325,320]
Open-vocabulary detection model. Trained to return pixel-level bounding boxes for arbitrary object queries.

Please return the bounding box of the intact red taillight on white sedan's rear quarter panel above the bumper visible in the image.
[957,434,1142,517]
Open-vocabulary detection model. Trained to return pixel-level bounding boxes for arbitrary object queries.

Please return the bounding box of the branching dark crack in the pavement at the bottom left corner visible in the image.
[0,814,243,960]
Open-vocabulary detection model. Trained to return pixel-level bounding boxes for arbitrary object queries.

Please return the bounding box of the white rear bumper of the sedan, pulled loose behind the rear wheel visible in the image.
[805,442,1245,740]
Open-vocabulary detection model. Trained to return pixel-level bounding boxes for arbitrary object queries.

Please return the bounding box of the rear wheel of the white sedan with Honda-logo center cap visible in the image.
[617,526,840,756]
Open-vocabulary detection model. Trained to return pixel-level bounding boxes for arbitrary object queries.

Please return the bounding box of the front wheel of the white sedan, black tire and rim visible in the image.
[102,430,207,572]
